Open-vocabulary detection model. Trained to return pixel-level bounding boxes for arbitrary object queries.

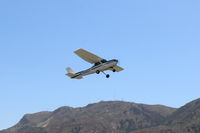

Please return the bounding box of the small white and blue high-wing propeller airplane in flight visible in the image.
[65,49,124,79]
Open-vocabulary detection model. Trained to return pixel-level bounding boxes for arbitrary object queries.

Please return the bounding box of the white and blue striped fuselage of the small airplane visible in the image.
[71,59,118,78]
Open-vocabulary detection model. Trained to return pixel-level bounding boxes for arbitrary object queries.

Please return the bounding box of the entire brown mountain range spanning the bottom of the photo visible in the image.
[0,99,200,133]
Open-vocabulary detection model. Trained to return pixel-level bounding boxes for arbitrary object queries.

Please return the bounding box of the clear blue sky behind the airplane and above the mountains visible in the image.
[0,0,200,129]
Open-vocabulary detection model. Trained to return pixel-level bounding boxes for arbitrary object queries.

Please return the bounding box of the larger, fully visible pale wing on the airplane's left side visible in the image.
[74,49,103,64]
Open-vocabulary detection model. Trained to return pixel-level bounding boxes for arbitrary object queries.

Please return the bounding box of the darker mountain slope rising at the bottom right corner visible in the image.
[131,98,200,133]
